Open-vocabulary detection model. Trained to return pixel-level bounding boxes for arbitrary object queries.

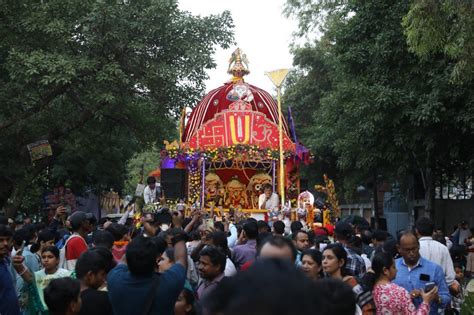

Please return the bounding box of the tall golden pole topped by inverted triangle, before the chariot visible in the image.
[265,69,289,206]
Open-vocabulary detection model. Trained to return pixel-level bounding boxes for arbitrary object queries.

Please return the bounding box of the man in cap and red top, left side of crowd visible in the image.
[64,211,93,271]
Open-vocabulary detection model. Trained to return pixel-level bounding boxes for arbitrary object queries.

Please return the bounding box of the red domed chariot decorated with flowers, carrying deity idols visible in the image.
[161,49,332,227]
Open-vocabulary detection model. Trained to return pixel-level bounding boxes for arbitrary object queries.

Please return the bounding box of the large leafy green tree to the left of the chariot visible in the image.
[0,0,233,215]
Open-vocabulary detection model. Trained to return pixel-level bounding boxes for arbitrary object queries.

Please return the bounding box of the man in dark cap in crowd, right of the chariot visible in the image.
[334,222,367,279]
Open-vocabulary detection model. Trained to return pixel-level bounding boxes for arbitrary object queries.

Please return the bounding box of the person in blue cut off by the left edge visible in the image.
[0,224,20,315]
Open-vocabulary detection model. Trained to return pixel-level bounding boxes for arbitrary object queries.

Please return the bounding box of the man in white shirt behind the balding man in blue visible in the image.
[415,217,459,293]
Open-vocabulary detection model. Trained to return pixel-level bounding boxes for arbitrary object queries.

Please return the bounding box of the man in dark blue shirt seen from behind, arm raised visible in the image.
[107,235,187,315]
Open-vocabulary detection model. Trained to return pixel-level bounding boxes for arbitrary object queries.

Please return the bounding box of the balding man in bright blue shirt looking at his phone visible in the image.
[393,232,451,315]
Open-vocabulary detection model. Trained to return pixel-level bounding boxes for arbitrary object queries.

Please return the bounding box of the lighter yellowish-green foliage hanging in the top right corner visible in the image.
[403,0,474,82]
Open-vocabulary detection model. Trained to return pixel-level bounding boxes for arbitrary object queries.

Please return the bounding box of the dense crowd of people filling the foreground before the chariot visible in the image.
[0,202,474,315]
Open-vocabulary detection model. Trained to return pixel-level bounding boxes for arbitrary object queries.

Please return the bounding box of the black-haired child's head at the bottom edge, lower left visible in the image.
[44,278,82,315]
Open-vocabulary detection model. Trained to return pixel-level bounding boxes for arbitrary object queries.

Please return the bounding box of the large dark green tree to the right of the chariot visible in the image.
[287,0,474,217]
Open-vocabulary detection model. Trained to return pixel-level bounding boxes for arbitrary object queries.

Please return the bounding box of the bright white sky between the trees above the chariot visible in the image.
[179,0,297,93]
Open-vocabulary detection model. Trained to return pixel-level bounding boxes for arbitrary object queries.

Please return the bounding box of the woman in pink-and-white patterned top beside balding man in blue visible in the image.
[372,252,438,315]
